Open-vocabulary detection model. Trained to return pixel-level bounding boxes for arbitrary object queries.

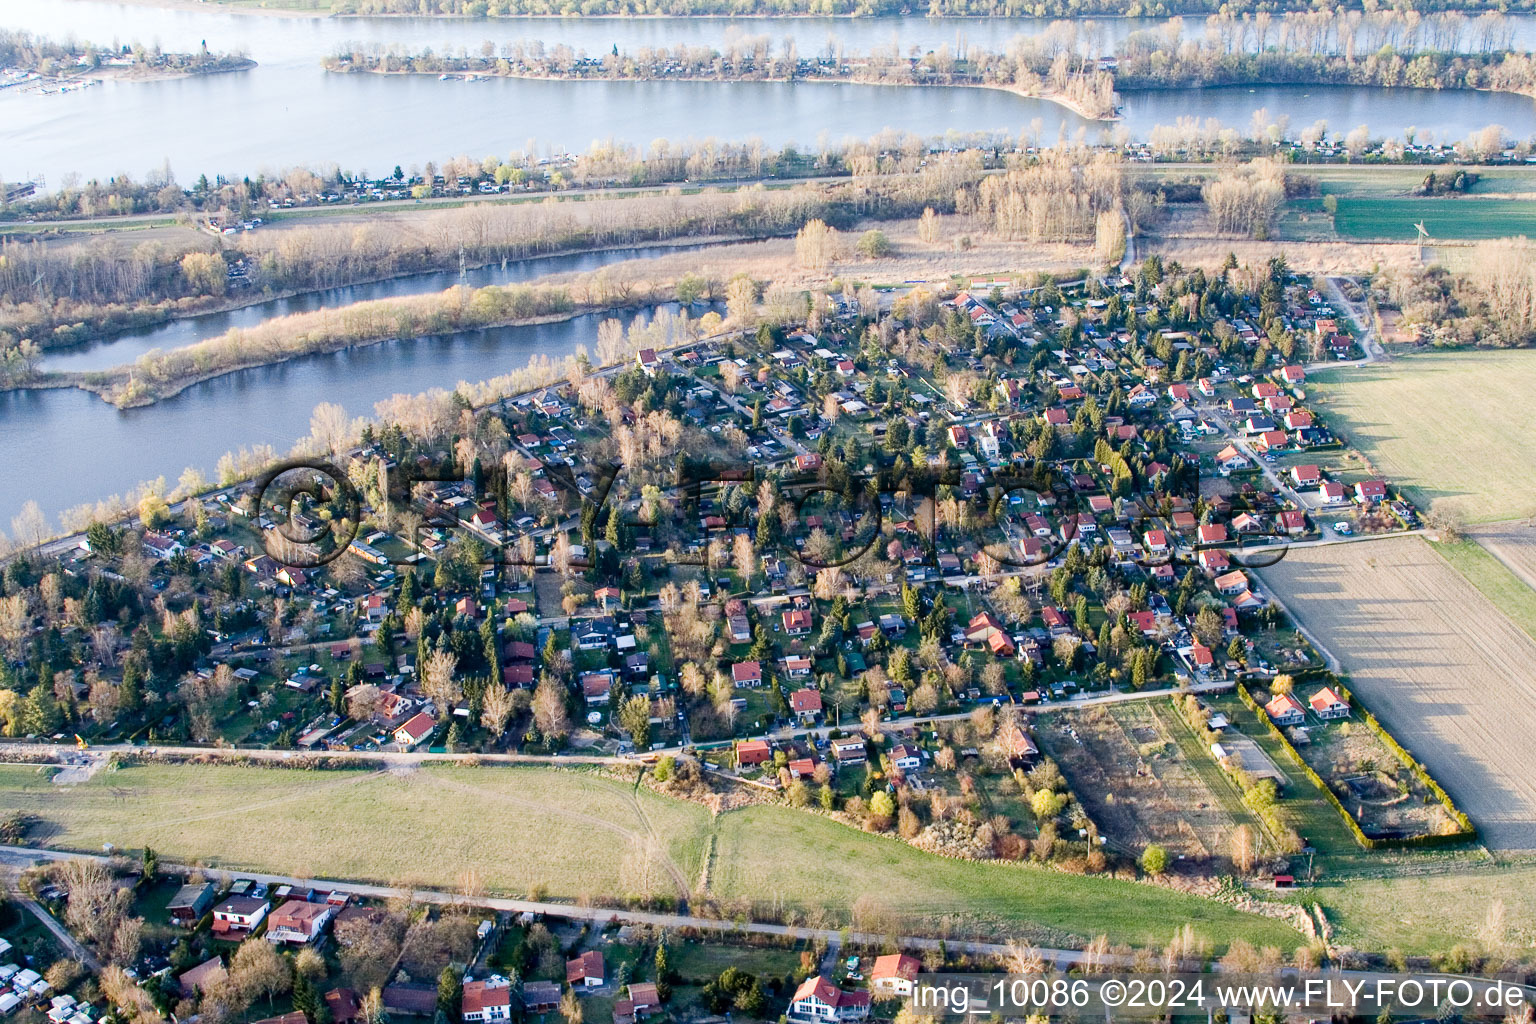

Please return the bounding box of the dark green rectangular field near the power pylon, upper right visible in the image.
[1333,197,1536,241]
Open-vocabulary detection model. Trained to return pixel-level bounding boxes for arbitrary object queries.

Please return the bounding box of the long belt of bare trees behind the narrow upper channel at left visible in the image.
[0,151,983,356]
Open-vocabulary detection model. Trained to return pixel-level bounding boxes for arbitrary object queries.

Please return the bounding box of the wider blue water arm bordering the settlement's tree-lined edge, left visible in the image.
[0,297,703,524]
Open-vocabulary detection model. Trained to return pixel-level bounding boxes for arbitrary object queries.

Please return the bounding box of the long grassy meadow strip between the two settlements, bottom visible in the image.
[0,765,1301,950]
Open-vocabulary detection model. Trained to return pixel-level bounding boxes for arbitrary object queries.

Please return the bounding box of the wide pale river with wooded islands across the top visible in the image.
[0,0,1536,187]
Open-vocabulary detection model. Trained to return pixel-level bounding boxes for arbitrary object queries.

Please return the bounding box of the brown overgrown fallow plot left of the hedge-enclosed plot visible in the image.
[1035,703,1255,861]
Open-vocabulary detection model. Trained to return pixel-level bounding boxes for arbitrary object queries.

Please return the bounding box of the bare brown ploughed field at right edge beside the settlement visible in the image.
[1260,537,1536,851]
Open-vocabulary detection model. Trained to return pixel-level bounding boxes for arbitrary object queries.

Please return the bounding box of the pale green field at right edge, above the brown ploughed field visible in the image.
[1307,350,1536,524]
